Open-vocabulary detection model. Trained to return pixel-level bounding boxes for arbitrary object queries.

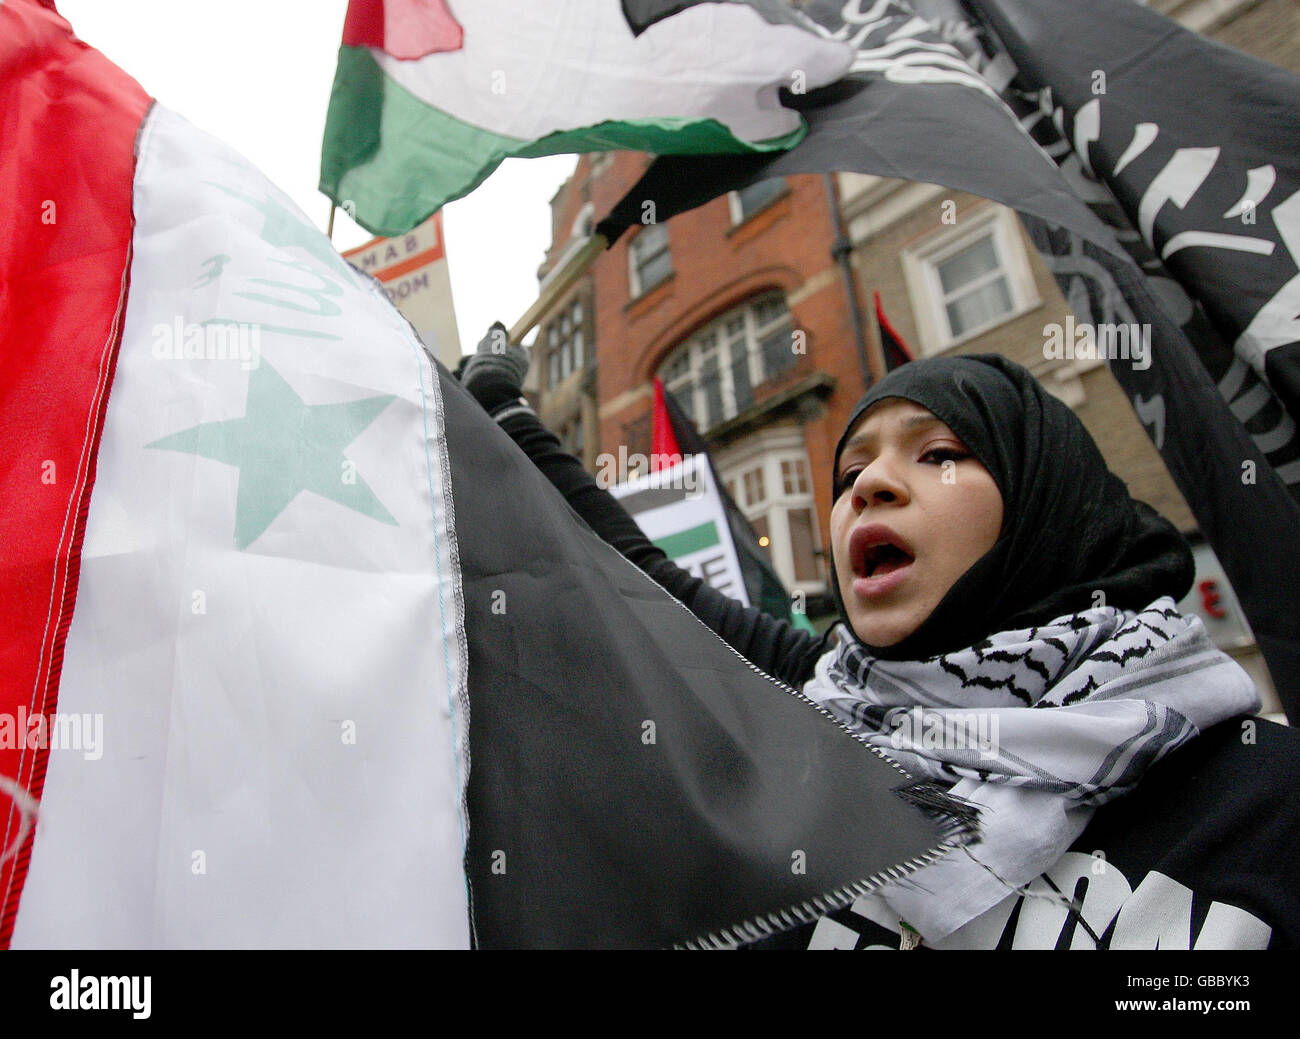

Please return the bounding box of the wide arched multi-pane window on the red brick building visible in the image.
[659,293,796,429]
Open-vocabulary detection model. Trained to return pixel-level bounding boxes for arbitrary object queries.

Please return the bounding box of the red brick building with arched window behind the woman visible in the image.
[536,159,866,606]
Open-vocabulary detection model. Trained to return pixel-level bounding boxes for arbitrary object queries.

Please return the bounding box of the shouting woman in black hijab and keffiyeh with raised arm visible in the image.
[462,334,1300,948]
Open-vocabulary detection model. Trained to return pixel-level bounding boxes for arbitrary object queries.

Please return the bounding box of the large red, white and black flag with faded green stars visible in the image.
[0,0,970,948]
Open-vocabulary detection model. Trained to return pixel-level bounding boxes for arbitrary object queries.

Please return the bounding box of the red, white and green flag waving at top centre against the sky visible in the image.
[320,0,853,235]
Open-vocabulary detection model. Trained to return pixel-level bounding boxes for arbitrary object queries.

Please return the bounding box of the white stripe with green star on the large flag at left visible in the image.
[13,107,469,948]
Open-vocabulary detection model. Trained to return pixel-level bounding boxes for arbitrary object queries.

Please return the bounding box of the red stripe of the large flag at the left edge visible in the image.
[0,0,150,948]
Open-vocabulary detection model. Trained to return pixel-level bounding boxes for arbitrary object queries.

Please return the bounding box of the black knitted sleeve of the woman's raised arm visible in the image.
[501,411,826,688]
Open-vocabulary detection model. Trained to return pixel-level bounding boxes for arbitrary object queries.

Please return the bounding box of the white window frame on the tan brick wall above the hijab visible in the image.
[902,204,1041,356]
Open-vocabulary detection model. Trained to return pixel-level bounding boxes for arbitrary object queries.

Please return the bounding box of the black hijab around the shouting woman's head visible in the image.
[831,354,1193,661]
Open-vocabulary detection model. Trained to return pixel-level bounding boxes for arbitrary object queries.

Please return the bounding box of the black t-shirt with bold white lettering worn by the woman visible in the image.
[748,718,1300,949]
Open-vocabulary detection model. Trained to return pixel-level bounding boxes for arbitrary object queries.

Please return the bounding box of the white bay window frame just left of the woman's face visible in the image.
[714,425,827,596]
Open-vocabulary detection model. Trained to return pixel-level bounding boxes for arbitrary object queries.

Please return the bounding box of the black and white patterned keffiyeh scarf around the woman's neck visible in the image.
[803,596,1258,941]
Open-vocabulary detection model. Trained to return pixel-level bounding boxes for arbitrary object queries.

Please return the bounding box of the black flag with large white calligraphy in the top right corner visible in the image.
[967,0,1300,460]
